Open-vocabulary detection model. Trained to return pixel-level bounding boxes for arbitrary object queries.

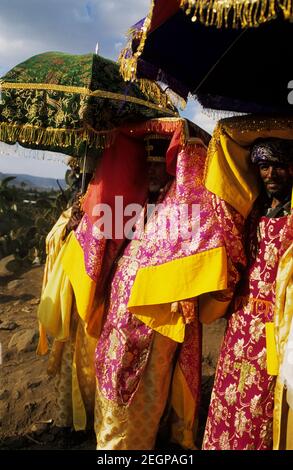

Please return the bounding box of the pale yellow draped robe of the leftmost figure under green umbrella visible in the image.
[37,208,96,430]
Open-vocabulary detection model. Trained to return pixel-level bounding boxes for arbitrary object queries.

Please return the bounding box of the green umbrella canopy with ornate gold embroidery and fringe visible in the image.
[0,52,177,156]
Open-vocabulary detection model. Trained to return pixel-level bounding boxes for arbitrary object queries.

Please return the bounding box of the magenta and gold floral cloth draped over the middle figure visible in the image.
[96,144,245,404]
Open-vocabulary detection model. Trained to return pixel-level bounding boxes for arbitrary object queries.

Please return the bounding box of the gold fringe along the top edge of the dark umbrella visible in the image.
[180,0,293,28]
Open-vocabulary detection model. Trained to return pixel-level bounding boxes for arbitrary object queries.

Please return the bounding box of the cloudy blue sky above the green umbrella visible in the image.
[0,0,150,72]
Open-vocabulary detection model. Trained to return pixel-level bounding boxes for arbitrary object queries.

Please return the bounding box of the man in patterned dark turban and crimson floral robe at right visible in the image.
[203,131,293,450]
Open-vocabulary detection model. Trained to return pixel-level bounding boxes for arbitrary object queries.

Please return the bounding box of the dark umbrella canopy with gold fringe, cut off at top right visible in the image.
[120,0,293,112]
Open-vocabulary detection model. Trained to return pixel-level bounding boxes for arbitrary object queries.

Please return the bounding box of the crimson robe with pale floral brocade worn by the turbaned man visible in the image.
[203,217,288,450]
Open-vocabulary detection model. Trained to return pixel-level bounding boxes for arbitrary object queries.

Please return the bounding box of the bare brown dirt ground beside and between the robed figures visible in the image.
[0,266,225,450]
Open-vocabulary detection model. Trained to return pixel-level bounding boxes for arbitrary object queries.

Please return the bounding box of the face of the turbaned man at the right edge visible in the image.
[259,162,293,198]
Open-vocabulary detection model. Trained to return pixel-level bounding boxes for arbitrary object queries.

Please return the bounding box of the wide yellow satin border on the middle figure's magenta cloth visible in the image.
[128,247,227,343]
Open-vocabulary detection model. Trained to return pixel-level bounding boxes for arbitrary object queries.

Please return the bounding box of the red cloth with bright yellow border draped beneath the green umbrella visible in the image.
[62,125,147,338]
